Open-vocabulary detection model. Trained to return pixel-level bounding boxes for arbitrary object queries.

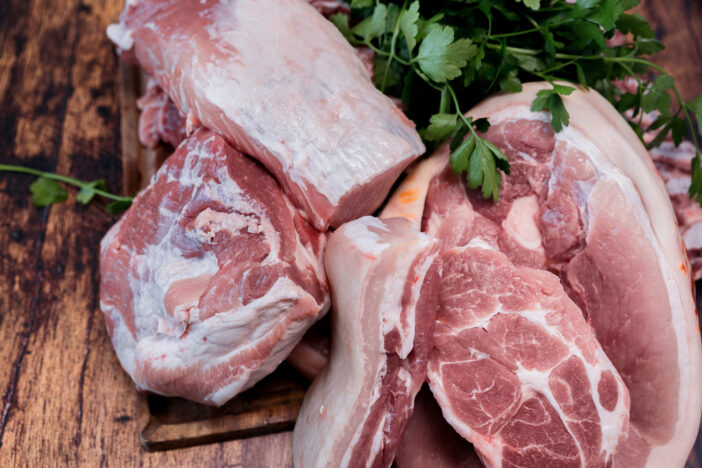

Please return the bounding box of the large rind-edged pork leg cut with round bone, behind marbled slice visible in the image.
[384,83,702,467]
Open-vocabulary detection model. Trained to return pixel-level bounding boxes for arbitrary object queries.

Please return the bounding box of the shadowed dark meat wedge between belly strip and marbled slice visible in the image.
[395,386,483,468]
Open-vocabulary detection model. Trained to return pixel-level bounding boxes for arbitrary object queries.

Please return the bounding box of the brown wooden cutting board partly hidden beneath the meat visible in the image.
[119,62,307,450]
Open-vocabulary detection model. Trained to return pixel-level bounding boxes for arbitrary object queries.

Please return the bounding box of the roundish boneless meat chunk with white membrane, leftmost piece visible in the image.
[100,129,330,405]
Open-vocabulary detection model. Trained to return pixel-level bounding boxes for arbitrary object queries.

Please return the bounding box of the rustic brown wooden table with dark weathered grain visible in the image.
[0,0,702,467]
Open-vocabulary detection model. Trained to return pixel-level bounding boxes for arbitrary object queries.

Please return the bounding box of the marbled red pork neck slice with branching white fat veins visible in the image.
[429,238,629,467]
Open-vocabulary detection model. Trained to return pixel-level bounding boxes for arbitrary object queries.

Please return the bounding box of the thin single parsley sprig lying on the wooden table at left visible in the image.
[0,164,133,214]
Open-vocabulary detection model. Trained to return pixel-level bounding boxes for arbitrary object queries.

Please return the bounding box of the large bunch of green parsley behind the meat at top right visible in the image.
[331,0,702,204]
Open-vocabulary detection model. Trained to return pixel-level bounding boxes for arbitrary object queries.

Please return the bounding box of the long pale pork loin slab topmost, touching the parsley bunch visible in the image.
[108,0,424,230]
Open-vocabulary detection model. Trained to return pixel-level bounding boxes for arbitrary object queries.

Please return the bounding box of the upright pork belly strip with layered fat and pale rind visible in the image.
[293,217,439,468]
